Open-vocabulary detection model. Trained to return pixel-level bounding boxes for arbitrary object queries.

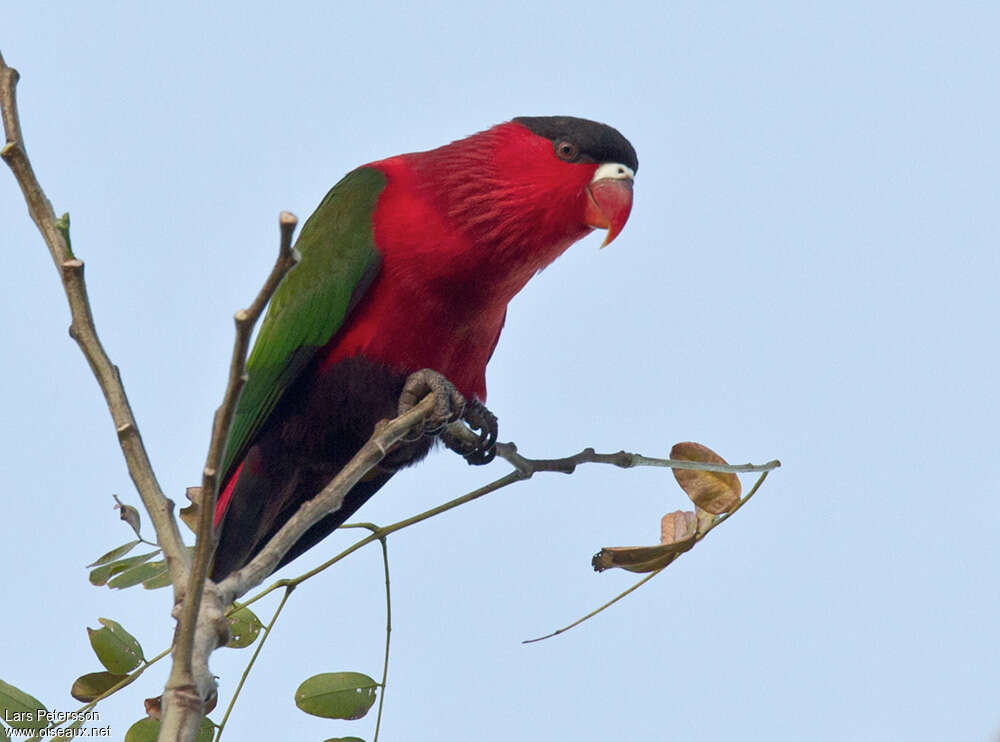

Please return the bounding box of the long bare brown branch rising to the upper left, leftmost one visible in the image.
[0,50,188,597]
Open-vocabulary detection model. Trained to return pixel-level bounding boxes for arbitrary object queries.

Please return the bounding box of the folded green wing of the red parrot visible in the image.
[222,167,385,477]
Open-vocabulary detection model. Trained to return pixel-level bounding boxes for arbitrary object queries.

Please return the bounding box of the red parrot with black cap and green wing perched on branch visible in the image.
[211,116,638,581]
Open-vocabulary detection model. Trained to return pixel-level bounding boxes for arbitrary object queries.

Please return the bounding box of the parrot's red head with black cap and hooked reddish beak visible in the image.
[406,116,639,258]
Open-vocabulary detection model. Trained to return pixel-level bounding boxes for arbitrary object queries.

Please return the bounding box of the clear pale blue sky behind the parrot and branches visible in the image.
[0,2,1000,742]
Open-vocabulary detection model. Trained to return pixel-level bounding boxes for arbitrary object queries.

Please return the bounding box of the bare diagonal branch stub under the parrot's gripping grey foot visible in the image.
[219,394,434,603]
